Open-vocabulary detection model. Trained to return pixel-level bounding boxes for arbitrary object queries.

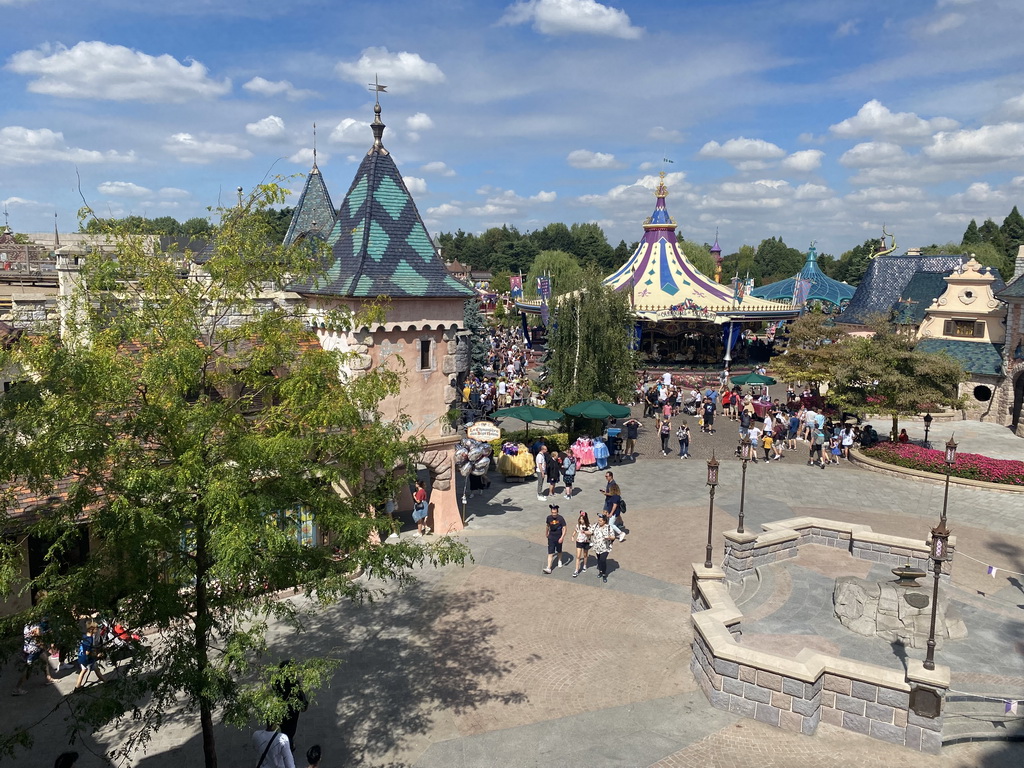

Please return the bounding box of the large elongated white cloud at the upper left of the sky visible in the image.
[7,41,231,103]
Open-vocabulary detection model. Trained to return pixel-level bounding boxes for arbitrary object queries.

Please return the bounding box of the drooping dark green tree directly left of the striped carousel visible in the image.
[548,267,636,408]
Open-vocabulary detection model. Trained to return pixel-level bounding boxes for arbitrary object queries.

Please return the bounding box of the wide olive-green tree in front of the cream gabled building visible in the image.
[827,319,966,440]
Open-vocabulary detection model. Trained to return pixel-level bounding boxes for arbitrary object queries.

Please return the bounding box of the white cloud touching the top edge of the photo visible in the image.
[499,0,643,40]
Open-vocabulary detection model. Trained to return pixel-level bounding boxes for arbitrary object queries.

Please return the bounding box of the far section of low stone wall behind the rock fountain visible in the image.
[722,517,956,581]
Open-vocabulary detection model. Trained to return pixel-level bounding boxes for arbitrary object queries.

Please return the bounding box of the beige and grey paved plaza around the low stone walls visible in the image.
[3,420,1024,768]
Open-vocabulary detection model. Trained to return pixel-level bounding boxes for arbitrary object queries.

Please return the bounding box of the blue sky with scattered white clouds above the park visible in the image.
[0,0,1024,255]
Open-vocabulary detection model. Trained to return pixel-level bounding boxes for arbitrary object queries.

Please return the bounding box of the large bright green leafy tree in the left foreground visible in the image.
[0,186,466,768]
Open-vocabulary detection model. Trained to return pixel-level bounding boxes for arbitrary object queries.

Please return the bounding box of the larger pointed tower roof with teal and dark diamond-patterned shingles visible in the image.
[292,125,476,299]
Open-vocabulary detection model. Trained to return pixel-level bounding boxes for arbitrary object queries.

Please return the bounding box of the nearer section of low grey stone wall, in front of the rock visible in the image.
[690,564,949,754]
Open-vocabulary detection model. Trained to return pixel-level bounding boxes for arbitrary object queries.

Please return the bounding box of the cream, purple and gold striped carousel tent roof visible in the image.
[604,173,800,324]
